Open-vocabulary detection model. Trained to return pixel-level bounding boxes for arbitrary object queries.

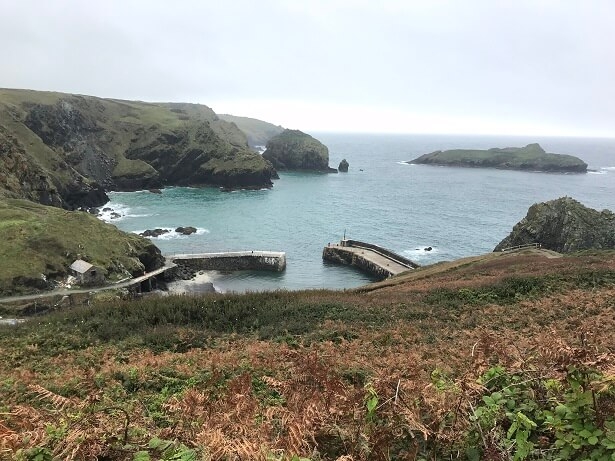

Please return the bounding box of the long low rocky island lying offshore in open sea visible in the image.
[406,143,587,173]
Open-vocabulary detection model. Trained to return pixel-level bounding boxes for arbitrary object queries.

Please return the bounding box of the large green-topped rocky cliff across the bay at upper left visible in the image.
[0,89,275,208]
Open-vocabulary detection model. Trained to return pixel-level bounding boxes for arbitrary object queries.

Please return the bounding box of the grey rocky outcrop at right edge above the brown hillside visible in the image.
[493,197,615,253]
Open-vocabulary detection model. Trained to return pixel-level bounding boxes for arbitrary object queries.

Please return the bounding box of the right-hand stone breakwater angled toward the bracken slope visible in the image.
[322,240,419,280]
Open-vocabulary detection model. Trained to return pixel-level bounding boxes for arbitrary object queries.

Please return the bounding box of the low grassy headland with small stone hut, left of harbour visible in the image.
[0,199,164,296]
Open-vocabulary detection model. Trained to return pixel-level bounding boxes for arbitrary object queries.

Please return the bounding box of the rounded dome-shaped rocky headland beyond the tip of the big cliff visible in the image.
[263,130,337,172]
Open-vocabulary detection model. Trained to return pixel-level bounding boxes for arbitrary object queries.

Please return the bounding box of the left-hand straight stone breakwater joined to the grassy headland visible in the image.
[167,251,286,272]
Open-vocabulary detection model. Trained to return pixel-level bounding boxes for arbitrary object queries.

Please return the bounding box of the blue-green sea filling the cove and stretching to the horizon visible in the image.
[101,133,615,292]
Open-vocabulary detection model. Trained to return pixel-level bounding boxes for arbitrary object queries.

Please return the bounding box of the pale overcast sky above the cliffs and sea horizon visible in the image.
[0,0,615,137]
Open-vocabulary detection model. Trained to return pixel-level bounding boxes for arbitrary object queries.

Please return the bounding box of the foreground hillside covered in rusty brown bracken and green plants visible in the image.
[0,250,615,461]
